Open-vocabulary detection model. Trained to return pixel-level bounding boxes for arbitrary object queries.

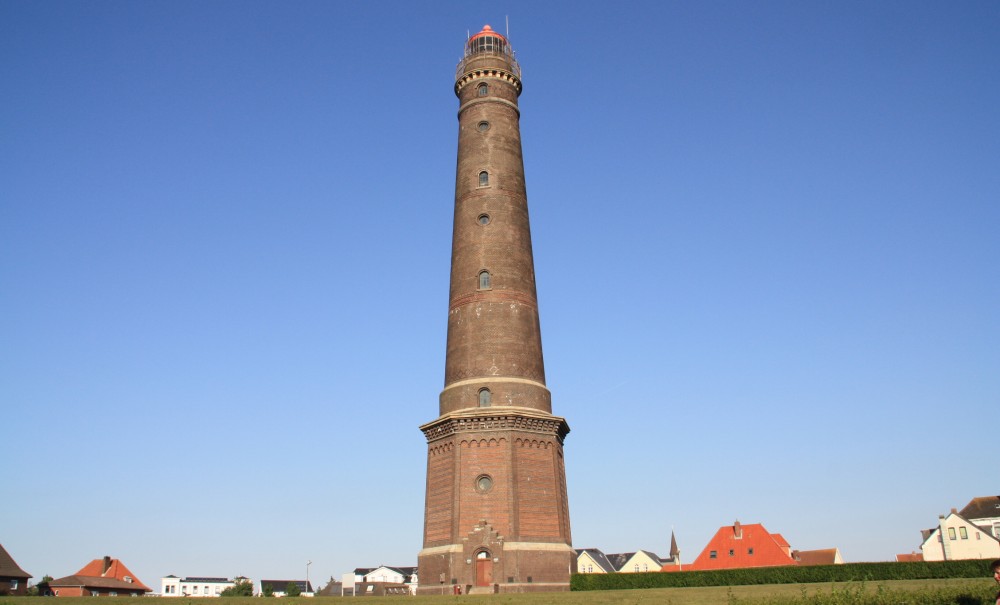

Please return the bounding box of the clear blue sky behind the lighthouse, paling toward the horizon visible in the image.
[0,0,1000,590]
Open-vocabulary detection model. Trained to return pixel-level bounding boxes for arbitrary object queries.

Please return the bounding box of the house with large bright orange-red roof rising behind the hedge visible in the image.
[661,521,798,571]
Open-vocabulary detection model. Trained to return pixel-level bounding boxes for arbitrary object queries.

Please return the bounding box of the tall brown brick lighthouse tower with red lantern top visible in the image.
[418,25,576,594]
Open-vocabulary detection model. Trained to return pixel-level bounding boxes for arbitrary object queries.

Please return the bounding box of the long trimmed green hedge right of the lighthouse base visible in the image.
[570,559,992,590]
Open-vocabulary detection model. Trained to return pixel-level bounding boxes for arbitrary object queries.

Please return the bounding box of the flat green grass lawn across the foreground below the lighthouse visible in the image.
[0,578,996,605]
